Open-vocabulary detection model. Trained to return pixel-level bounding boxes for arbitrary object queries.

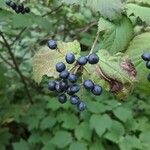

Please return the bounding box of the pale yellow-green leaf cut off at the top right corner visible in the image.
[126,4,150,25]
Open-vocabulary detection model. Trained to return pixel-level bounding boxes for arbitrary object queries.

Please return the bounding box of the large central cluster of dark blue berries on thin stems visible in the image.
[48,40,102,111]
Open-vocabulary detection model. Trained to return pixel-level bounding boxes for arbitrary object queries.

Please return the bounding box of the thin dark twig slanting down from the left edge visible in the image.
[0,31,33,104]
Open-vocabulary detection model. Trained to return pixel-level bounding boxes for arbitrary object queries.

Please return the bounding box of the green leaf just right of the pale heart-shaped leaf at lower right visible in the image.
[105,120,125,143]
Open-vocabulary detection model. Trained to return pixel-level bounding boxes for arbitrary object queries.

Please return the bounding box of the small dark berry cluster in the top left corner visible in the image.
[5,0,30,14]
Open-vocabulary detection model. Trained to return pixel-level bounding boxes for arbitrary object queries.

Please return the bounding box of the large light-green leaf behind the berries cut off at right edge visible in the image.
[126,32,150,94]
